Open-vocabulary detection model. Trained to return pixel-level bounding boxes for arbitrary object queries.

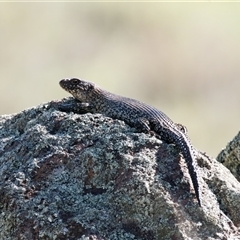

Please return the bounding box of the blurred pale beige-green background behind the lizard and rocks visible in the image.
[0,2,240,157]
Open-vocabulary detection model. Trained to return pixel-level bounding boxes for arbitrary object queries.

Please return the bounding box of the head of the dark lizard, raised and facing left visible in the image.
[59,78,95,102]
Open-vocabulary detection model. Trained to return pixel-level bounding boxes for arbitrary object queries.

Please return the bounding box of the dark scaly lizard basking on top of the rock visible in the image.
[59,78,201,206]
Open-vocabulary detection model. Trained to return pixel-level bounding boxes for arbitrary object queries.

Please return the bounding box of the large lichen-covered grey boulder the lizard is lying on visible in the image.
[0,98,240,240]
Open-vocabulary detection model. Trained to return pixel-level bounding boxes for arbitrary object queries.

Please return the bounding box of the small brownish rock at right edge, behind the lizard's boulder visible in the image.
[217,132,240,181]
